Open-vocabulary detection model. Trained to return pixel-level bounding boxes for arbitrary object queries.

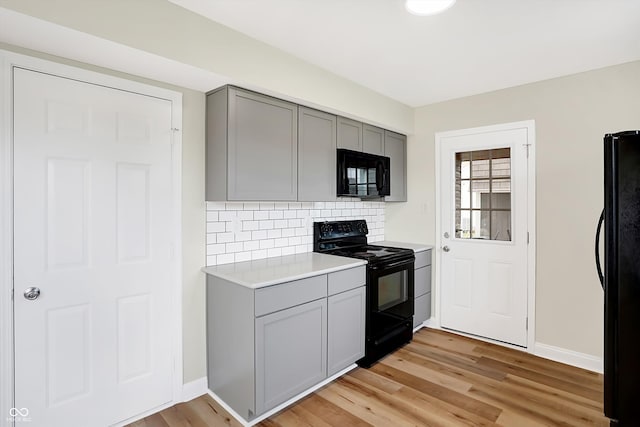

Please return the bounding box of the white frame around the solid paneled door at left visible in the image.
[0,50,183,421]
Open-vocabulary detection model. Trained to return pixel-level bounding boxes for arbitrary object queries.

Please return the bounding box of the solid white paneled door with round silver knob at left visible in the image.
[14,68,174,426]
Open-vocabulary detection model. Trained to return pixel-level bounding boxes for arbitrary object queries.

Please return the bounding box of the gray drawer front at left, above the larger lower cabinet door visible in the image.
[255,274,327,317]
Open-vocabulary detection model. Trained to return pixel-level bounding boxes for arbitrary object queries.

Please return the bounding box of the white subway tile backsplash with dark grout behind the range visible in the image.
[206,198,385,265]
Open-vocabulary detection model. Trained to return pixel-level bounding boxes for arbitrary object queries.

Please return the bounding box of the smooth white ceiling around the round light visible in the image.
[170,0,640,107]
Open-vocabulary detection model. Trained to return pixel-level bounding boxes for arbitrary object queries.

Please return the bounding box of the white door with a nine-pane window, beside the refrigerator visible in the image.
[439,123,529,346]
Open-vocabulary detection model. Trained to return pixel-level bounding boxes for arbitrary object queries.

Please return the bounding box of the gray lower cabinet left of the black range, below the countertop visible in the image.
[207,266,366,421]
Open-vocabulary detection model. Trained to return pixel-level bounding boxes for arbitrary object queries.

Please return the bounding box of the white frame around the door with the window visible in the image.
[436,120,536,353]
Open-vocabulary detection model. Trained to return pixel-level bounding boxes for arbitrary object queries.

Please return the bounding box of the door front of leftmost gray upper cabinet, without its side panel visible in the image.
[227,88,298,200]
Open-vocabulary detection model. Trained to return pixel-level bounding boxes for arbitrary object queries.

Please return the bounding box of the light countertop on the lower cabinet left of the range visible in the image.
[202,252,367,289]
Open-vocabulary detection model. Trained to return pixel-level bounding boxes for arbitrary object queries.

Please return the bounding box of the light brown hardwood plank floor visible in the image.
[131,329,608,427]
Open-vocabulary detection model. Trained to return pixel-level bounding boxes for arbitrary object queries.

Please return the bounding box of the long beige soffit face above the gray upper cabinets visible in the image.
[0,0,413,132]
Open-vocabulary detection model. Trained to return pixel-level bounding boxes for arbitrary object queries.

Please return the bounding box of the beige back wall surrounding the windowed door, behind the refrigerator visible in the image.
[385,62,640,357]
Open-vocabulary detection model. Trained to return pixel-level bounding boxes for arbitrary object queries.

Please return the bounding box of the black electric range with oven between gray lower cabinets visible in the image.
[313,220,415,367]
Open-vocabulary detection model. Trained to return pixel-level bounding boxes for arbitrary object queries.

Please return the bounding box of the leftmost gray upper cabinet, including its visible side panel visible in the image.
[206,86,298,200]
